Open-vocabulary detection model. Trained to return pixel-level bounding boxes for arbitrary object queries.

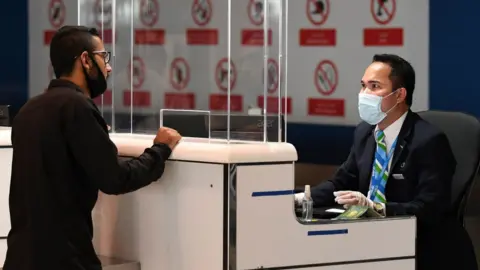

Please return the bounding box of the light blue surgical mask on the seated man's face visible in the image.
[358,91,398,125]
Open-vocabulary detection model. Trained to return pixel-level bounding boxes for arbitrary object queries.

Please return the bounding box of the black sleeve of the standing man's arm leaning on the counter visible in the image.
[65,100,171,194]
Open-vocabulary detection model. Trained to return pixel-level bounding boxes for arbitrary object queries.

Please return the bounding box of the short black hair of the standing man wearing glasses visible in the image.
[50,26,100,78]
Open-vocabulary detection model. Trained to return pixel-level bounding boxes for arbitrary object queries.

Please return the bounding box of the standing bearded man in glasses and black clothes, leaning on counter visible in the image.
[4,26,181,270]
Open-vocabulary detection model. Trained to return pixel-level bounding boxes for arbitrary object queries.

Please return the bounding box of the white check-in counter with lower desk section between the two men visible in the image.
[93,134,416,270]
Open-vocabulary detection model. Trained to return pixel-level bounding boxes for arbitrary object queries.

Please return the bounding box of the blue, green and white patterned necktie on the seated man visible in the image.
[370,130,389,203]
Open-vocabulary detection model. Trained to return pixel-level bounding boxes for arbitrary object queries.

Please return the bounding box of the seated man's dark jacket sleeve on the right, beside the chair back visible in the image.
[386,133,456,224]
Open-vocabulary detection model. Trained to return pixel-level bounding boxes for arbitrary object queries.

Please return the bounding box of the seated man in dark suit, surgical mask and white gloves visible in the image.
[295,54,477,270]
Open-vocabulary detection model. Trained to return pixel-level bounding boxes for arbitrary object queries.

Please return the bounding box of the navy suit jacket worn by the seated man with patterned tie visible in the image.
[312,111,456,223]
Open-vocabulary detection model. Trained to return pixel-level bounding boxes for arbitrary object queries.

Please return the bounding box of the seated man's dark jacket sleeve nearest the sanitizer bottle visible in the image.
[311,147,359,206]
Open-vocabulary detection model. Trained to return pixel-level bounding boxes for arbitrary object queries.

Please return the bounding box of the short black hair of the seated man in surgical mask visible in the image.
[372,54,415,106]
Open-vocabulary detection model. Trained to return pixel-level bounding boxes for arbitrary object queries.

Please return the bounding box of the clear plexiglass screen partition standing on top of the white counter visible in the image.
[78,0,292,142]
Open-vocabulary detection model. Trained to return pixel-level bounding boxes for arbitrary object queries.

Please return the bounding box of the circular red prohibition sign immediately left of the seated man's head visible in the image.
[313,60,338,96]
